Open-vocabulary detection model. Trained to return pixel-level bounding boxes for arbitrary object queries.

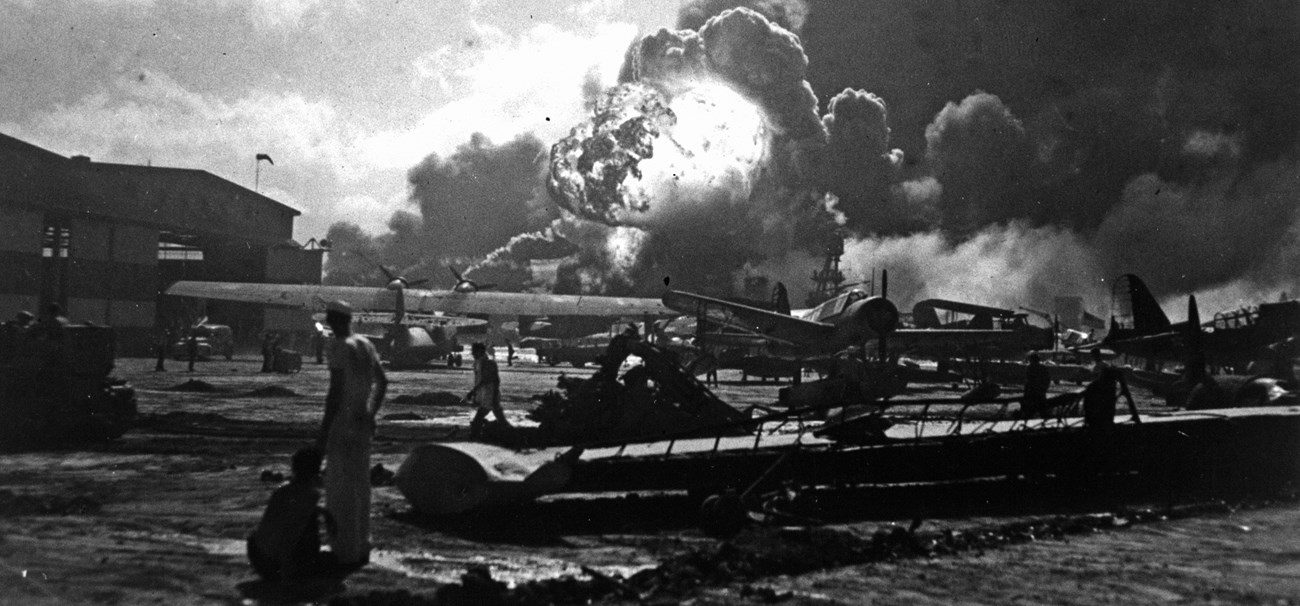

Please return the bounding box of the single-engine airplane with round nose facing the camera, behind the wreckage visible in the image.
[663,273,1052,360]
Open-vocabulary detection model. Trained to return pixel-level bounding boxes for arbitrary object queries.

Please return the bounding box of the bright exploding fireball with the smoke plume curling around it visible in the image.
[550,8,832,293]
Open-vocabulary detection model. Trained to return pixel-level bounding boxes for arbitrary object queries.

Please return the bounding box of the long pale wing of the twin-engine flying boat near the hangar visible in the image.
[166,280,677,319]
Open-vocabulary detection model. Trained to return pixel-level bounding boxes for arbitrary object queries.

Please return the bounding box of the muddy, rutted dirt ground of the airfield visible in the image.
[0,358,1300,605]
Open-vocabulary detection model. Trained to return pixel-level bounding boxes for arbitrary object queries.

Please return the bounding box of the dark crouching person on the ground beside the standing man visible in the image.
[248,449,338,581]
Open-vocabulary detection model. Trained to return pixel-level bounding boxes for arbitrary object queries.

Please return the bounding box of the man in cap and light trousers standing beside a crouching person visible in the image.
[316,300,389,568]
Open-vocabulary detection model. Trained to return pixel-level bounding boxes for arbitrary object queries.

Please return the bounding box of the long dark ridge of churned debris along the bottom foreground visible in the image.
[329,498,1294,606]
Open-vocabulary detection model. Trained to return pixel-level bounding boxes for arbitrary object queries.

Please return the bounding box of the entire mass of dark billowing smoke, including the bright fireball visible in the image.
[332,0,1300,322]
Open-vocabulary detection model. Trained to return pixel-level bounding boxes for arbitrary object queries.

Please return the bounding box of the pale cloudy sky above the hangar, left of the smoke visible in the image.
[0,0,679,241]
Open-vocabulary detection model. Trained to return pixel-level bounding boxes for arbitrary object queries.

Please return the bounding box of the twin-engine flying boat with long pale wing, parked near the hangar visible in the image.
[166,270,676,367]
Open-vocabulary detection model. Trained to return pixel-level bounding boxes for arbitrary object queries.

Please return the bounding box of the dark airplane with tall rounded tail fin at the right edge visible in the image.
[1099,273,1300,371]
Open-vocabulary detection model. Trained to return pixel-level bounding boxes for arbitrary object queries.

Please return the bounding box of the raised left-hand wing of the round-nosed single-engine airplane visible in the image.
[663,290,835,345]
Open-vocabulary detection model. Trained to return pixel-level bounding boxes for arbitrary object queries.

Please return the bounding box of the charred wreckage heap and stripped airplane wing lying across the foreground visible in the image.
[395,279,1300,529]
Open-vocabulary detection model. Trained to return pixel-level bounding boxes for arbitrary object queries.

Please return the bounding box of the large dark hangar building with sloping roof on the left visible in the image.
[0,134,324,355]
